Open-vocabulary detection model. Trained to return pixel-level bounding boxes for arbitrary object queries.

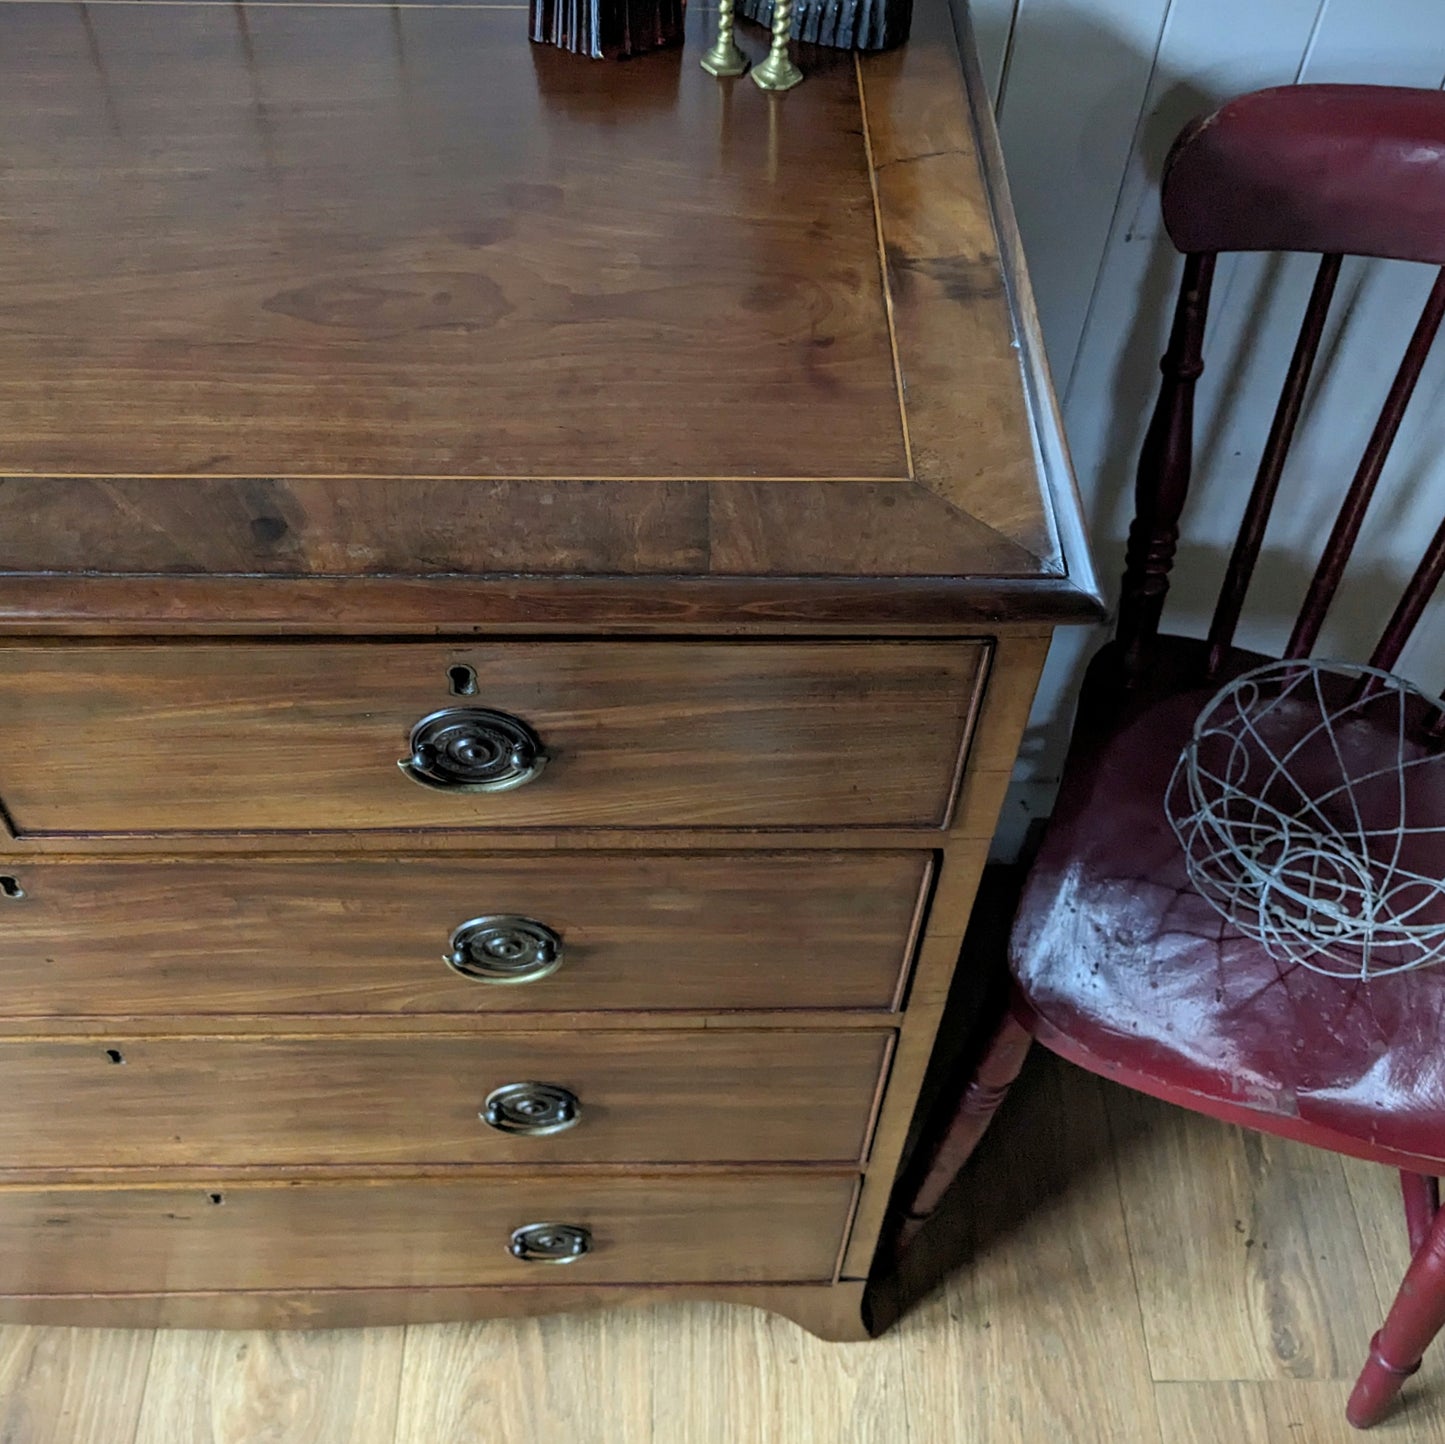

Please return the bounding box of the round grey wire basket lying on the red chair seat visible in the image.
[1166,661,1445,979]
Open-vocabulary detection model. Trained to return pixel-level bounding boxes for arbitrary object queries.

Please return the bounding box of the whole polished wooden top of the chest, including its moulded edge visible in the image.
[0,0,1092,630]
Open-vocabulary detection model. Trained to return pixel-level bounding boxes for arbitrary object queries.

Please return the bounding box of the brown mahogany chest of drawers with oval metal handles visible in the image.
[0,0,1097,1337]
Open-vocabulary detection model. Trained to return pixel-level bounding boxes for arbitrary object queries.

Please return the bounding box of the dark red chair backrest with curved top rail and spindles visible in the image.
[1118,85,1445,688]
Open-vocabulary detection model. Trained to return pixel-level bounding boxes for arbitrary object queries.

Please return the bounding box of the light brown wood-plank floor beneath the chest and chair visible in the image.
[0,1054,1445,1444]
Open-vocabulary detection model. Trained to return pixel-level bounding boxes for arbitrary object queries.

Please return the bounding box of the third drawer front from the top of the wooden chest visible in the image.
[0,1031,892,1168]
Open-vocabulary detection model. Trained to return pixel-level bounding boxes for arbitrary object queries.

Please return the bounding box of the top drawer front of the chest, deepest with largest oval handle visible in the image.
[0,642,987,837]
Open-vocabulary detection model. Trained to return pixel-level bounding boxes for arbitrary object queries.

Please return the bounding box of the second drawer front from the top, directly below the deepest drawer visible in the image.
[0,851,931,1018]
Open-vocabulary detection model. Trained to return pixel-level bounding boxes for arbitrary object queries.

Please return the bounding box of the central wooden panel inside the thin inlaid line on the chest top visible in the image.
[0,4,907,482]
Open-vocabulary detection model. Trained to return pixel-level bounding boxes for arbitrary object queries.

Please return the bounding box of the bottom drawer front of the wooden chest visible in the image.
[0,1174,857,1294]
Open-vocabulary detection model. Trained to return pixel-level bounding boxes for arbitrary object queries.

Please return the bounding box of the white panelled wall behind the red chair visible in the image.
[972,0,1445,856]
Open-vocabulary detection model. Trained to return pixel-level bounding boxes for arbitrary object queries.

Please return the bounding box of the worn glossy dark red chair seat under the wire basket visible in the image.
[1012,637,1445,1174]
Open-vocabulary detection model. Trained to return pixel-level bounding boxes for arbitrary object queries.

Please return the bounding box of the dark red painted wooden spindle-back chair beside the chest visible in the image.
[903,85,1445,1427]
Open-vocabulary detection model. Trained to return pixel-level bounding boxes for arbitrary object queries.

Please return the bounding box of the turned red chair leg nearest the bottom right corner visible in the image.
[1345,1174,1445,1430]
